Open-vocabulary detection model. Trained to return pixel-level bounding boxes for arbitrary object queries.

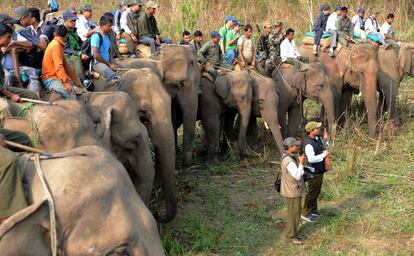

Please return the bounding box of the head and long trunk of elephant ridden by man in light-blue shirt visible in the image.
[121,68,177,222]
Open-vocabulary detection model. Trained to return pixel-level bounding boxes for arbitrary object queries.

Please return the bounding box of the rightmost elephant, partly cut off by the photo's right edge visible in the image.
[378,43,414,127]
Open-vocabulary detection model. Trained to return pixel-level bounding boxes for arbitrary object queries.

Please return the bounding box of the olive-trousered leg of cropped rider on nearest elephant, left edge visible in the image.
[0,128,32,225]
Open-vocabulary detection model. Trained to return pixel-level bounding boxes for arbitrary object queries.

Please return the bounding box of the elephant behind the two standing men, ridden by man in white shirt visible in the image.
[273,63,335,138]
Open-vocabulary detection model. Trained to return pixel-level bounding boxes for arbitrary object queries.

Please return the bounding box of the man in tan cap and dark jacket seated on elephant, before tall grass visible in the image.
[138,1,172,54]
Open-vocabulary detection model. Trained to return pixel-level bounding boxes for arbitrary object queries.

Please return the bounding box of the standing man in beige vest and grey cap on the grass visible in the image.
[280,137,306,245]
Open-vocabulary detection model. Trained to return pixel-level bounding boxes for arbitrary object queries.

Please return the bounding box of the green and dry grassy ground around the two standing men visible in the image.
[159,81,414,255]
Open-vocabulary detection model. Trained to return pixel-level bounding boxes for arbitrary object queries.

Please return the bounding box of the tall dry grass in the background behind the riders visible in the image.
[0,0,414,40]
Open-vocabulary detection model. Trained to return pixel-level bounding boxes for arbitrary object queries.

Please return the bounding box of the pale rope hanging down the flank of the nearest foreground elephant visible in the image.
[34,154,57,256]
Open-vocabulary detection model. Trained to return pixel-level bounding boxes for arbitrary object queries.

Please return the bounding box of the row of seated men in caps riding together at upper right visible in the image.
[312,5,399,57]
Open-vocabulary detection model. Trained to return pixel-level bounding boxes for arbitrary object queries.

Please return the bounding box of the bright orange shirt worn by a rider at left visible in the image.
[42,37,81,87]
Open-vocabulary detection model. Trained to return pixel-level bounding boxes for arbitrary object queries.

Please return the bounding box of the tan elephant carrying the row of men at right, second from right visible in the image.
[299,44,378,137]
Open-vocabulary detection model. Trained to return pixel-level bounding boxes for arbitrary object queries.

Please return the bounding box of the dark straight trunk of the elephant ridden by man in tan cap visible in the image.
[177,88,198,166]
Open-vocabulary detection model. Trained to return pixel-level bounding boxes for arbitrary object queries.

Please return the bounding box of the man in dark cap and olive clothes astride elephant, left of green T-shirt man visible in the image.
[197,31,233,80]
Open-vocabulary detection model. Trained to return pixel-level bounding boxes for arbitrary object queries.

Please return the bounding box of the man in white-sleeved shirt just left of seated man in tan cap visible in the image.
[120,0,142,58]
